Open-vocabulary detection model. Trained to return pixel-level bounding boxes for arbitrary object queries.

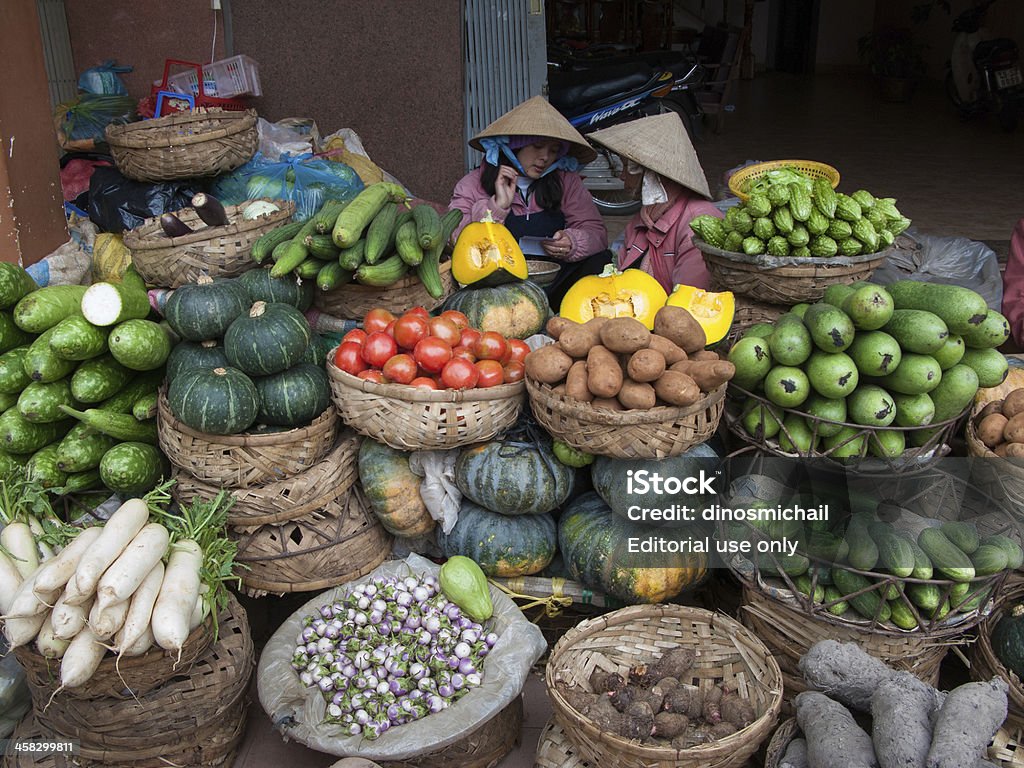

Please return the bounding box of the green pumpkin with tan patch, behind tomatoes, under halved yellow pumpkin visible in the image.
[444,281,551,339]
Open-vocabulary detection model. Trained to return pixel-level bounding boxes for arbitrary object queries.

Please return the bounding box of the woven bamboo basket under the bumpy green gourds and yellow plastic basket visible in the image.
[693,237,888,306]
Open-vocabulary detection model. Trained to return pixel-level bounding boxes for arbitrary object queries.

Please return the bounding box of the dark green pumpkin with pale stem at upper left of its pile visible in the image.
[164,274,252,341]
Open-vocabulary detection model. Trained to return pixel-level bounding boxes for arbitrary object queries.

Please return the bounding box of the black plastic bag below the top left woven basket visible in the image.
[89,168,199,233]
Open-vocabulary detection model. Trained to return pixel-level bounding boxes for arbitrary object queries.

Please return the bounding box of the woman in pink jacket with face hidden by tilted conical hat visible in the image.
[591,113,722,293]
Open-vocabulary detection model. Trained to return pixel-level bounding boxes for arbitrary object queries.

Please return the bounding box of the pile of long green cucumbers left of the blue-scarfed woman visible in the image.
[252,181,462,299]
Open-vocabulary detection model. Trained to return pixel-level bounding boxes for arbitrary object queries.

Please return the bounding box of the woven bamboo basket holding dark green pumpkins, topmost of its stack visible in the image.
[157,388,340,488]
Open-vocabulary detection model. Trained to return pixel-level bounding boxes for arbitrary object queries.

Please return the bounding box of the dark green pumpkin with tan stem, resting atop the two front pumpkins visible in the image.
[224,301,312,376]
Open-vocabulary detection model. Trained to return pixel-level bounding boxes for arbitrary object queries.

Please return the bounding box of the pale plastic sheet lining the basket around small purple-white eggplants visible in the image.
[257,555,547,761]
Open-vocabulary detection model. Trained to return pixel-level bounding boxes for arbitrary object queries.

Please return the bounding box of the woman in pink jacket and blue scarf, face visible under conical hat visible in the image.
[449,96,611,311]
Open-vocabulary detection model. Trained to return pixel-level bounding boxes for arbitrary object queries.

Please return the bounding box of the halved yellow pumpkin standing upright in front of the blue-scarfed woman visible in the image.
[452,211,528,288]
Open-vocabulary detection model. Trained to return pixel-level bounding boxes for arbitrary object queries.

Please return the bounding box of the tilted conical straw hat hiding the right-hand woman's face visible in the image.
[590,112,711,198]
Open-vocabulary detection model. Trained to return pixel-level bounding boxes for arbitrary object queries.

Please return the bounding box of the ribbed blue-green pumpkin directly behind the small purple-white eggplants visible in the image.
[437,499,558,578]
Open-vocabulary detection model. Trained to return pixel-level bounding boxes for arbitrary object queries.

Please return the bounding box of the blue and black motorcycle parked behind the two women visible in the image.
[548,52,705,216]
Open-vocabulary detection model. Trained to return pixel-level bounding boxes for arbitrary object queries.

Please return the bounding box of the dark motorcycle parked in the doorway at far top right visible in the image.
[946,0,1024,131]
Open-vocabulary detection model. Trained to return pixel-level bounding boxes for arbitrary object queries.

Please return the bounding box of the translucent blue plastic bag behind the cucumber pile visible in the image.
[211,153,362,221]
